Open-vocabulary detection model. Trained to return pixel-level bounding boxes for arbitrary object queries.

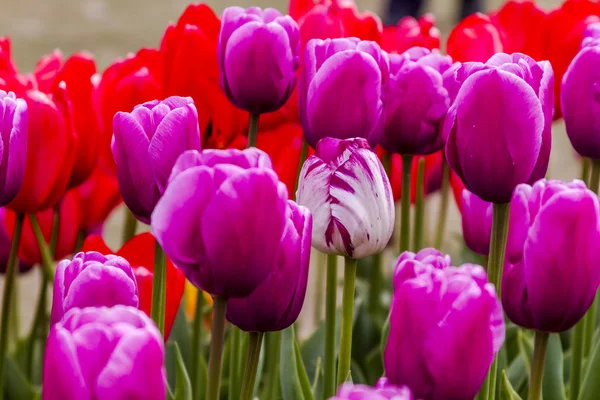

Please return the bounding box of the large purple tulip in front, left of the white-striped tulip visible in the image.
[152,149,290,298]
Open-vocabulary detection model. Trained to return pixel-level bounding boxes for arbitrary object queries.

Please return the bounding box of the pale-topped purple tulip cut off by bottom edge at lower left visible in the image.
[42,306,166,400]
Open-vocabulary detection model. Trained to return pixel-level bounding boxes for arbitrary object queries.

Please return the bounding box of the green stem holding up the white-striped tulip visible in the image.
[337,257,358,386]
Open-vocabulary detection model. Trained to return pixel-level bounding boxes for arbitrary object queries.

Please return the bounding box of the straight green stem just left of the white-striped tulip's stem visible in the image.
[323,254,337,399]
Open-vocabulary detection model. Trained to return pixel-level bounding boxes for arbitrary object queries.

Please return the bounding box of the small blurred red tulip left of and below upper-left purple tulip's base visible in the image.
[77,167,123,234]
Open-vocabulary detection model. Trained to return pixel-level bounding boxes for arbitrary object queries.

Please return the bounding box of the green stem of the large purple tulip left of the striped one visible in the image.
[206,296,227,400]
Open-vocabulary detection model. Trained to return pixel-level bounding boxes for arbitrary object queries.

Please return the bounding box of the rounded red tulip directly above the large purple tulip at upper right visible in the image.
[447,13,504,62]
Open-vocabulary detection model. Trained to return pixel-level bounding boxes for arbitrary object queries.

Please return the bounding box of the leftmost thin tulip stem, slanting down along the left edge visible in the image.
[0,214,25,400]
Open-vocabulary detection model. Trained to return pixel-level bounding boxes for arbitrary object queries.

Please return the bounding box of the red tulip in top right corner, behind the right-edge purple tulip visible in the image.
[545,0,600,118]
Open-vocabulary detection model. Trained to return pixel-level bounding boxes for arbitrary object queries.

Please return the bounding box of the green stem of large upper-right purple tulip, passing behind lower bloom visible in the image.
[484,203,510,400]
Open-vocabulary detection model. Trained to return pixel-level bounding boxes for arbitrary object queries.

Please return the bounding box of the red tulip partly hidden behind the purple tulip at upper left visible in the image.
[96,49,163,175]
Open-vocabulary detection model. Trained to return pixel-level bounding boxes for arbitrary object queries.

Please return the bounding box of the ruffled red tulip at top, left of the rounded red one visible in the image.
[381,14,440,53]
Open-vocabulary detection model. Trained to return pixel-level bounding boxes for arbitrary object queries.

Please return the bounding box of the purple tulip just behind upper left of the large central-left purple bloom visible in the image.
[112,96,200,224]
